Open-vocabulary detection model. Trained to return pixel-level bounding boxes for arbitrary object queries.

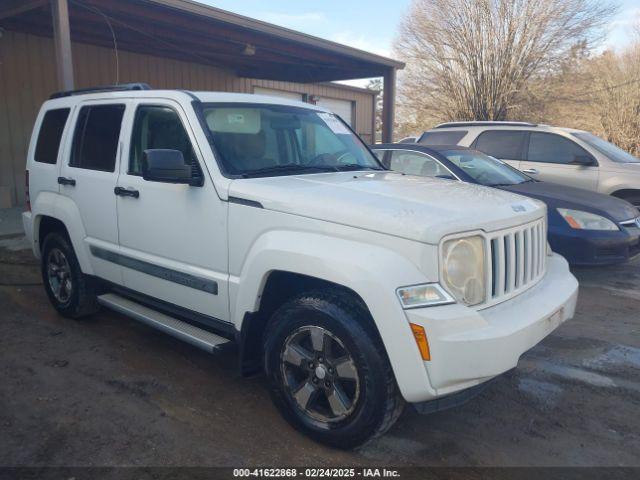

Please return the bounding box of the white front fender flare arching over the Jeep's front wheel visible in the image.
[229,231,440,401]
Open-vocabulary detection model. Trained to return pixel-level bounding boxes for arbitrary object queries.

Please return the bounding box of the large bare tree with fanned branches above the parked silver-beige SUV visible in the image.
[395,0,616,130]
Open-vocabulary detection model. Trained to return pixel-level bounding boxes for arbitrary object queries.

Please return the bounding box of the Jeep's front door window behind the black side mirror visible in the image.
[128,105,199,175]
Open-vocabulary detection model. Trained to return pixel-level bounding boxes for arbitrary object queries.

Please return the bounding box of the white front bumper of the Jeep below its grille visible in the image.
[402,255,578,402]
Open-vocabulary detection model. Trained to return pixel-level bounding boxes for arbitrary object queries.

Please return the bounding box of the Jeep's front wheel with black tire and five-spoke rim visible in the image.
[265,291,404,449]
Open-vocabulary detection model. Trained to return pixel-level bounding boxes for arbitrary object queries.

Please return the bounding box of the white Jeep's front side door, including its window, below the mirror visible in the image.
[116,100,229,326]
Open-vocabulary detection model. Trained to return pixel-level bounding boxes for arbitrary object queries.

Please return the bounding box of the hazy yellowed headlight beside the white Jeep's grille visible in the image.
[442,236,486,305]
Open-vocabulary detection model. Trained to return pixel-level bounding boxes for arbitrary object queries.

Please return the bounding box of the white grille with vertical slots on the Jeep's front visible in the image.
[484,218,547,306]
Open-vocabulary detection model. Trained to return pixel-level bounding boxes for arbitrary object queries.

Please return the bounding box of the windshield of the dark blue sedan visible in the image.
[440,150,532,187]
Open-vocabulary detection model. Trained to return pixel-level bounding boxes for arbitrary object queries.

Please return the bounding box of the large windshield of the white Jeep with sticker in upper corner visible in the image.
[201,103,383,177]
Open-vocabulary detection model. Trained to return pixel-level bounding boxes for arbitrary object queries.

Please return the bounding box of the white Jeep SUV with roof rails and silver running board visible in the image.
[23,84,578,448]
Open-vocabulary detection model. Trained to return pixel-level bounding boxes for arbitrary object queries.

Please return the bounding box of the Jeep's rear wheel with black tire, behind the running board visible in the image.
[40,232,99,318]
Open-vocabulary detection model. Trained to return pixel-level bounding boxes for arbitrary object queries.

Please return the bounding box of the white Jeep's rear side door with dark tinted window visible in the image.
[58,100,127,284]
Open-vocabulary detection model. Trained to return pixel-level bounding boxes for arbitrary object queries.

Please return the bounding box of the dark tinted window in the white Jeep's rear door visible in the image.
[69,105,125,172]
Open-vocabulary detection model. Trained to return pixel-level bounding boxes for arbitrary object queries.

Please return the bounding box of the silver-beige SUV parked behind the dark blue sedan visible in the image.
[418,122,640,208]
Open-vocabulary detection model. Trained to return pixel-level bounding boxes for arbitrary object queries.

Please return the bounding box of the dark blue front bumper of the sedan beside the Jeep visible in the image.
[549,226,640,266]
